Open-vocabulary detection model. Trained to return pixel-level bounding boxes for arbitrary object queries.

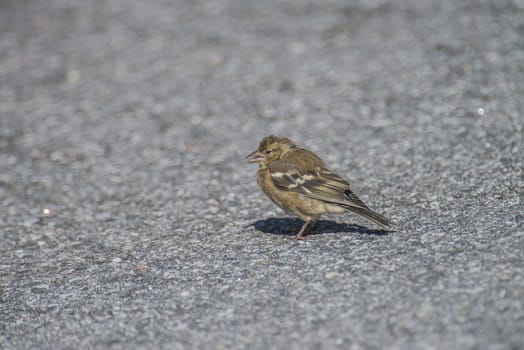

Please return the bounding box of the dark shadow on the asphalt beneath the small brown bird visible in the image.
[248,218,391,236]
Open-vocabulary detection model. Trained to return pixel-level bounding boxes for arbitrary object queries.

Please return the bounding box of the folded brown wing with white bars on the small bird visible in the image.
[268,160,367,209]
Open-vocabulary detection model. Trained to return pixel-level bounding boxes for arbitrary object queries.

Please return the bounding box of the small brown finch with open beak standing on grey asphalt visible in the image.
[247,135,392,239]
